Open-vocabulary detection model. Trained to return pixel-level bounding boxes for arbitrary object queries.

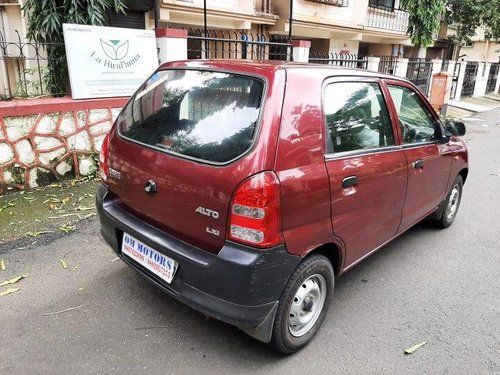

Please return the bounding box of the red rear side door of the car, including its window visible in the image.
[323,78,407,267]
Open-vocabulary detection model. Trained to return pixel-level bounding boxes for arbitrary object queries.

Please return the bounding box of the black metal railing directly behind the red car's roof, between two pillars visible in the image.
[188,29,293,61]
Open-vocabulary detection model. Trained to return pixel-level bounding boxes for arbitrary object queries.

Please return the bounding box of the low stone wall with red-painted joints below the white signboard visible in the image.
[0,99,124,194]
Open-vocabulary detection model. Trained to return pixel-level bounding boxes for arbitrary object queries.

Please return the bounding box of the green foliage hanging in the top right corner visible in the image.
[445,0,500,44]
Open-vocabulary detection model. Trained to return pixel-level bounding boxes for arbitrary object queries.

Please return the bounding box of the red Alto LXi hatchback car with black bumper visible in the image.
[97,61,468,353]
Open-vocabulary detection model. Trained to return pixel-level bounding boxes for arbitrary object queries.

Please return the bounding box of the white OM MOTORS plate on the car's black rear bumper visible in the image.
[122,233,178,284]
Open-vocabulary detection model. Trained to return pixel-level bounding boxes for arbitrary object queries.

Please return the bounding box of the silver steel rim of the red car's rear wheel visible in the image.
[288,274,326,337]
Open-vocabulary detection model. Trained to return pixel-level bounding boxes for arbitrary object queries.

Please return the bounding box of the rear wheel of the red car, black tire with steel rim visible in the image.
[270,254,335,354]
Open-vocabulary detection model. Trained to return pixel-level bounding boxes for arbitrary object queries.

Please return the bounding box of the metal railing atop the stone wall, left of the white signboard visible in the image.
[0,30,66,100]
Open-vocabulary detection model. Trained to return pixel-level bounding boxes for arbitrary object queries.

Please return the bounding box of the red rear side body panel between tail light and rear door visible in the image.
[275,69,342,256]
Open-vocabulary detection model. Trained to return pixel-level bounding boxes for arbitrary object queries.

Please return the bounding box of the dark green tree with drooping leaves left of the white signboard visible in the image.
[22,0,125,95]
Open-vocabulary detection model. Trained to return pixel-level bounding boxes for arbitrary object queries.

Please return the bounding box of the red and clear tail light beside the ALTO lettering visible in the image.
[228,171,283,248]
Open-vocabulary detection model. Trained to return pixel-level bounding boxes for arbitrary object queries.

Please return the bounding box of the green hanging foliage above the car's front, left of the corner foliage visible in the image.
[400,0,445,47]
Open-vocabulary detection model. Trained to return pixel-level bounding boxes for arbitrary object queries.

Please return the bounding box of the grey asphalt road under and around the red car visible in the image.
[0,109,500,374]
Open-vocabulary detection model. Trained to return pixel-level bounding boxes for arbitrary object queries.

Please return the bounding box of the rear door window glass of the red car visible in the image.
[324,82,394,152]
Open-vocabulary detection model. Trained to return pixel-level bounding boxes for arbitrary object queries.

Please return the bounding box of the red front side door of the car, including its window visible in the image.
[386,81,453,232]
